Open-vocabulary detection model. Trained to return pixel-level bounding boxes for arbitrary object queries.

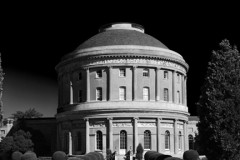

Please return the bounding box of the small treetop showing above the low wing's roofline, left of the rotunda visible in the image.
[12,108,43,119]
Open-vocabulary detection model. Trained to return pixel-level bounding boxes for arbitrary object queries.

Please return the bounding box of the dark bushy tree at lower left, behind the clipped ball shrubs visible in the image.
[0,130,34,153]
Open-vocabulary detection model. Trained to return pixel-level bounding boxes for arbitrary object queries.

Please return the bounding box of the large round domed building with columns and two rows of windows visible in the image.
[56,23,189,159]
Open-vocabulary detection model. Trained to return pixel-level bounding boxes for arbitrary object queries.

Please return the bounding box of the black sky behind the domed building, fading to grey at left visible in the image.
[0,4,240,117]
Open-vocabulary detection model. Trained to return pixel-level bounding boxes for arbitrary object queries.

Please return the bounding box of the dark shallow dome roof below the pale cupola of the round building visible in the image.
[76,29,168,50]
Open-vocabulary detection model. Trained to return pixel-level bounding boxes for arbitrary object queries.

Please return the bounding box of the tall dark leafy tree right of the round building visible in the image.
[195,40,240,160]
